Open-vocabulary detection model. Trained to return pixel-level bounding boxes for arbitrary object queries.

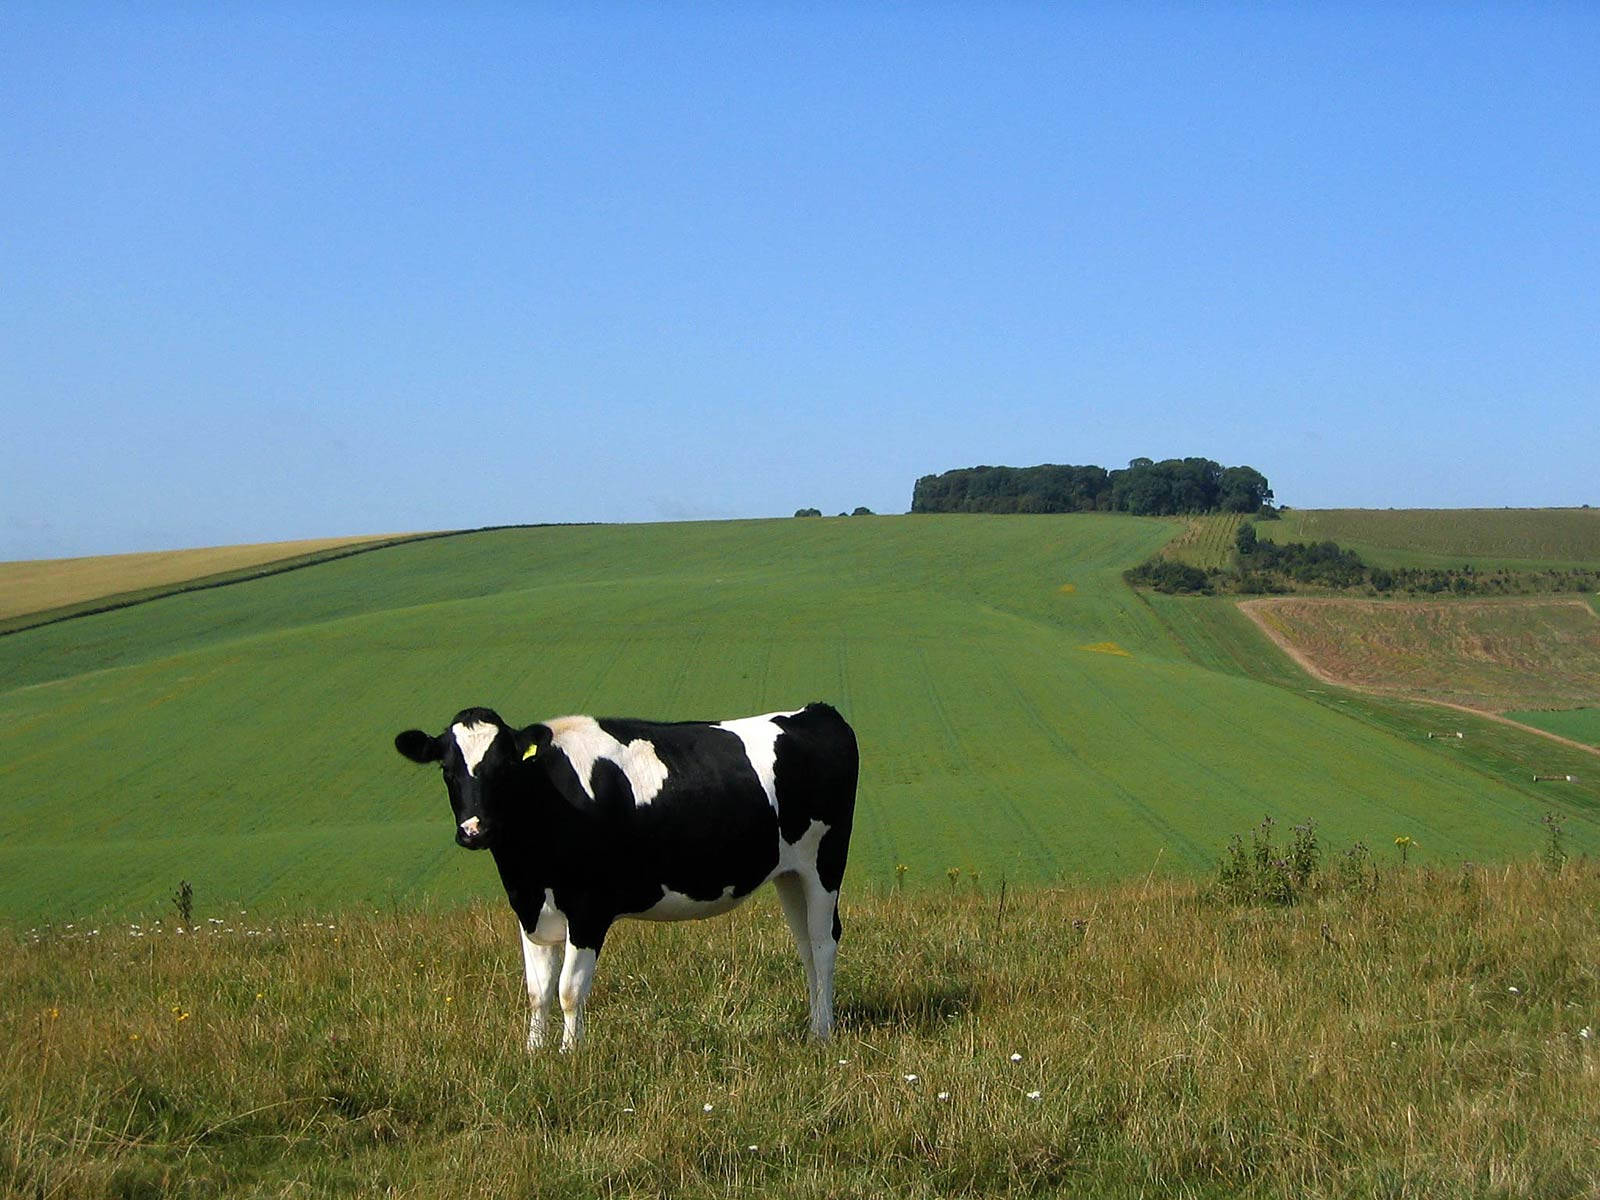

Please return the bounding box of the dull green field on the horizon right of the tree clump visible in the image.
[1256,509,1600,570]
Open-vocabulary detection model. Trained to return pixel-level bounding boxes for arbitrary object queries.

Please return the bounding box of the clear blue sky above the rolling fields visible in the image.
[0,3,1600,558]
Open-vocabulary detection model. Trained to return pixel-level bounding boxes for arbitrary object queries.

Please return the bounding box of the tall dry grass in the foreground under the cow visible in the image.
[0,864,1600,1197]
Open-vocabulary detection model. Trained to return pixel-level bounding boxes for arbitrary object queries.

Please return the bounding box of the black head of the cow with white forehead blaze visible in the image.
[395,709,550,850]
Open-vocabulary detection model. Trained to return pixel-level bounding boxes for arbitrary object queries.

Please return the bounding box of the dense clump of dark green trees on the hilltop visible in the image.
[910,458,1272,517]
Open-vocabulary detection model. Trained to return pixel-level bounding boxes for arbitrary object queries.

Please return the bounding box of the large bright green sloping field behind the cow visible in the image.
[0,515,1600,918]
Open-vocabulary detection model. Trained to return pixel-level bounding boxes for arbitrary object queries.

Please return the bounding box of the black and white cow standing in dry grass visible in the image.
[395,704,858,1050]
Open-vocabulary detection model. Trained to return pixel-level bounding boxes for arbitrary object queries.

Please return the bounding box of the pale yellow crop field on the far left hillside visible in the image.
[0,534,392,619]
